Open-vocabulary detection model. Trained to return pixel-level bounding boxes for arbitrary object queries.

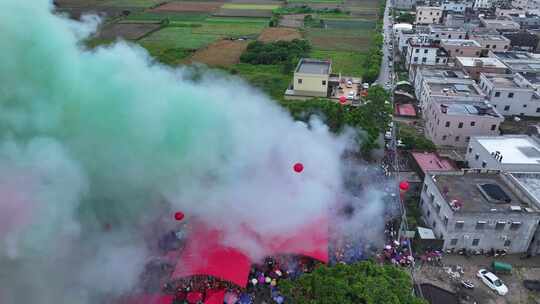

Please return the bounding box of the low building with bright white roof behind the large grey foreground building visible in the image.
[465,135,540,172]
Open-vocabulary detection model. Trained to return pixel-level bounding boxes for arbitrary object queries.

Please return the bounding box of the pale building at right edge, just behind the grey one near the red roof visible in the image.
[480,74,540,117]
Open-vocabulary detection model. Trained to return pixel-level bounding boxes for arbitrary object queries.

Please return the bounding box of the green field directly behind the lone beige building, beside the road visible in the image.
[310,50,366,77]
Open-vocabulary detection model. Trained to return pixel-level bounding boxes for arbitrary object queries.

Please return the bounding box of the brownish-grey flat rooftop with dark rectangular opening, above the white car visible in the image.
[432,171,537,213]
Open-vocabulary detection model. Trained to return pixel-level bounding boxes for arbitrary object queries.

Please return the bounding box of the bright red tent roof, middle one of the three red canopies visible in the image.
[172,223,251,286]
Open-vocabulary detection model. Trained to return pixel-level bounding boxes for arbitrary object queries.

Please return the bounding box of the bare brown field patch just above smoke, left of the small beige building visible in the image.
[190,40,249,66]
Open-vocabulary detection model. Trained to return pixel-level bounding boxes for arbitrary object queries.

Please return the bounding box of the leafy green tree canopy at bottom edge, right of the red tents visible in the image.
[280,261,426,304]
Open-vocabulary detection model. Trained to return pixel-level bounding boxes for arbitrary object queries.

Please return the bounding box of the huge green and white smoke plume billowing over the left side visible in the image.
[0,0,388,304]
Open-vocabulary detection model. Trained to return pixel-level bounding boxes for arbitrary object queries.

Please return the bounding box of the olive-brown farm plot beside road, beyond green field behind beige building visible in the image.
[306,28,372,51]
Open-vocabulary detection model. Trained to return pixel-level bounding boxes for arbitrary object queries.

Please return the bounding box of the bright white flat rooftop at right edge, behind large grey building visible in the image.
[474,135,540,165]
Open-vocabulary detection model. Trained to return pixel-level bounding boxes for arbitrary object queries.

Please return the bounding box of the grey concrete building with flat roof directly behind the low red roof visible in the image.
[423,98,504,147]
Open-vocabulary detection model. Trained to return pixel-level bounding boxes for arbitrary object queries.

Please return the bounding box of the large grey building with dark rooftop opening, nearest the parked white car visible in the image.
[420,169,540,254]
